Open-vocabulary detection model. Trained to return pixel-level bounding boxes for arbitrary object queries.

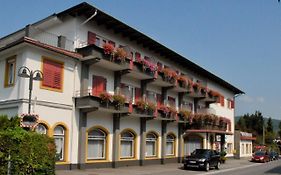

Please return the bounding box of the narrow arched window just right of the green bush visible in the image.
[54,125,65,161]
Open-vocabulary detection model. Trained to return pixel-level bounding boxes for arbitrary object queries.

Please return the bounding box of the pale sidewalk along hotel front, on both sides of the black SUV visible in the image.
[56,158,252,175]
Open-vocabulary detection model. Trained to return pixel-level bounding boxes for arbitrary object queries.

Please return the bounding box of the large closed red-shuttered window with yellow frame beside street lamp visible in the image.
[42,58,63,91]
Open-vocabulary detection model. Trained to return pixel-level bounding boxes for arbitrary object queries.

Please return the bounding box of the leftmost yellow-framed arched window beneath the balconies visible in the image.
[88,129,107,159]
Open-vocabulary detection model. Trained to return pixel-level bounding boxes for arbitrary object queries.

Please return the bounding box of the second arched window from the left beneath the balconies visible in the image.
[120,131,135,158]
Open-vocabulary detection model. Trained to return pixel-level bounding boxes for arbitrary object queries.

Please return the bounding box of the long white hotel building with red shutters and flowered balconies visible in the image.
[0,3,243,169]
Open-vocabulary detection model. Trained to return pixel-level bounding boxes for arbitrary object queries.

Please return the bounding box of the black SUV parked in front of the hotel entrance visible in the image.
[184,149,221,171]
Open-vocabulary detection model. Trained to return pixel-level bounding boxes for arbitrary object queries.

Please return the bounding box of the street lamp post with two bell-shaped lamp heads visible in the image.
[18,66,43,114]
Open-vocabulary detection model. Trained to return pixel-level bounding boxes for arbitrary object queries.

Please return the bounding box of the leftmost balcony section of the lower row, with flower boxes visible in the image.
[75,89,129,114]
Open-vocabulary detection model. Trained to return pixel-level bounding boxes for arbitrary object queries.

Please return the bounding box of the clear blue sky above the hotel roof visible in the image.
[0,0,281,119]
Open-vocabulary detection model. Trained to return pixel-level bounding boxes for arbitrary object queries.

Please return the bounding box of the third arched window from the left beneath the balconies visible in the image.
[146,133,157,157]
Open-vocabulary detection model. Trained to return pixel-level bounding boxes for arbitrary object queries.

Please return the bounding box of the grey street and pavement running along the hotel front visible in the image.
[56,159,281,175]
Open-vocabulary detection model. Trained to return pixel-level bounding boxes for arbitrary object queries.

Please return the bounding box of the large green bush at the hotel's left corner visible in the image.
[0,116,56,175]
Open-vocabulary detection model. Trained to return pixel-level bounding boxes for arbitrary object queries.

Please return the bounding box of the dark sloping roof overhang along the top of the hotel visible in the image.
[57,2,244,94]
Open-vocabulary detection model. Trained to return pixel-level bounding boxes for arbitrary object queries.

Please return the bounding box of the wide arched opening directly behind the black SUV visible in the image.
[184,134,203,156]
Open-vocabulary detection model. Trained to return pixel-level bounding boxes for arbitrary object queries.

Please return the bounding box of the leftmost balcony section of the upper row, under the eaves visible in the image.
[77,45,132,71]
